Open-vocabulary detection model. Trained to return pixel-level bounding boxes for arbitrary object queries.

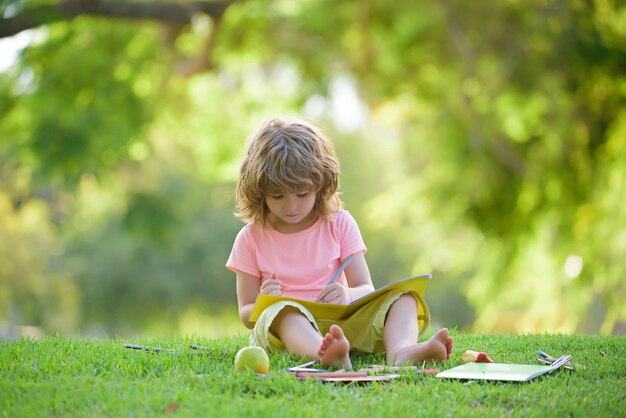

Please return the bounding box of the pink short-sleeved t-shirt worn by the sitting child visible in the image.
[226,210,367,300]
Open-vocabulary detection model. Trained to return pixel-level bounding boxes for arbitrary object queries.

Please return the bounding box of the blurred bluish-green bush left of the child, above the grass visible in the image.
[67,181,238,335]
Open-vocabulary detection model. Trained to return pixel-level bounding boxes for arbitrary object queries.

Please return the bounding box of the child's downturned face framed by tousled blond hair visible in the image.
[265,187,316,232]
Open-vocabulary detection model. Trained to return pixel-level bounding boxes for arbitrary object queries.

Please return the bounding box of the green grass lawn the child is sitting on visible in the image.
[0,332,626,417]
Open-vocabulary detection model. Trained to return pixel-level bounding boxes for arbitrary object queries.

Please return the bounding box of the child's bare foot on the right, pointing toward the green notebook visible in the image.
[387,328,454,365]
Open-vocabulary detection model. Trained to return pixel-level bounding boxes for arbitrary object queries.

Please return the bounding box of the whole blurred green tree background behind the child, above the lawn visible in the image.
[0,0,626,338]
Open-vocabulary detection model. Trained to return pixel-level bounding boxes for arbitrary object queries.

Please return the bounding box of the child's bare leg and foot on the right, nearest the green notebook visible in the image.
[383,294,454,365]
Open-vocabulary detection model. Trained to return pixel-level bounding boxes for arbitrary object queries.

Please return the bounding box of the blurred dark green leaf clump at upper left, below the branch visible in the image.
[4,19,164,183]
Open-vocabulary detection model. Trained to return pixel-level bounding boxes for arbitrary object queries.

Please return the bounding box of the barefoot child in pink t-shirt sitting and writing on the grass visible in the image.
[226,118,453,368]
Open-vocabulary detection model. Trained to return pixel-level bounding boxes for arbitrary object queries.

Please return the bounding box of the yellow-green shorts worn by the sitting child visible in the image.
[250,290,430,353]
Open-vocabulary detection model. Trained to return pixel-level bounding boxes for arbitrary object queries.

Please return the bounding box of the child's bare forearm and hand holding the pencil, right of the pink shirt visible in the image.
[317,252,375,305]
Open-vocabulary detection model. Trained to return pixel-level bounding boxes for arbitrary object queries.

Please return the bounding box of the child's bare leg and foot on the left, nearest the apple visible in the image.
[271,308,352,368]
